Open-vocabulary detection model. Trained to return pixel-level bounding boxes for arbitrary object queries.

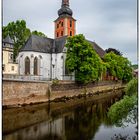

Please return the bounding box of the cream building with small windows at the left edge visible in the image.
[2,42,18,75]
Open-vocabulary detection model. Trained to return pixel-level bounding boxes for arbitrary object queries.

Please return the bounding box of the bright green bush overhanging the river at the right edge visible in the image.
[108,79,138,126]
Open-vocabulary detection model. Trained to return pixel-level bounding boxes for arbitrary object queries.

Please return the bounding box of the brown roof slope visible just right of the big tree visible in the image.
[87,40,105,58]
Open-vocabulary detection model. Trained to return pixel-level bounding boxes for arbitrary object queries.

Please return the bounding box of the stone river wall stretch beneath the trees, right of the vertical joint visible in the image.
[50,81,125,100]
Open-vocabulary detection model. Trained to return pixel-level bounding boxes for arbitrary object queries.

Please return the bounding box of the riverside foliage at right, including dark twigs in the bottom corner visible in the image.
[108,79,138,140]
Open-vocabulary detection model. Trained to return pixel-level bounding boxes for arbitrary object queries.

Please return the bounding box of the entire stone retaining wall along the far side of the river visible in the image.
[2,80,125,107]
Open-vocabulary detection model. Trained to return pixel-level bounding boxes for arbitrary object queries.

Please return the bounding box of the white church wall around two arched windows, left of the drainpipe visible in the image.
[17,51,51,79]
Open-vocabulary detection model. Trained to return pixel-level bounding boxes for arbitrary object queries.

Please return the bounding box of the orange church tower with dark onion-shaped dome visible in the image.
[54,0,76,38]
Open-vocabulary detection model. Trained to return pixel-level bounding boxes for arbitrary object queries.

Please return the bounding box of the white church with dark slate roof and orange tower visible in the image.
[17,0,105,80]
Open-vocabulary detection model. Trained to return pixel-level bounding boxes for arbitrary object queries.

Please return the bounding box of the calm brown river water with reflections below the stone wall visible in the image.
[3,93,137,140]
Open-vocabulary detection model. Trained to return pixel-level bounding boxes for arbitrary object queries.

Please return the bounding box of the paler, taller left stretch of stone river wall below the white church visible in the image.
[2,80,49,105]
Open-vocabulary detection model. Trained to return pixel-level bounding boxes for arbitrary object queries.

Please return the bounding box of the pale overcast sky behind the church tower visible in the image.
[3,0,137,64]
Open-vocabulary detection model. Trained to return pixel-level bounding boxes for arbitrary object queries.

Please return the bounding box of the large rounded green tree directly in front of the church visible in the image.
[66,34,103,84]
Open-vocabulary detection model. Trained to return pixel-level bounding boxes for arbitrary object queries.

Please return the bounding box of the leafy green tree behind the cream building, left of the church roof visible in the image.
[2,20,45,60]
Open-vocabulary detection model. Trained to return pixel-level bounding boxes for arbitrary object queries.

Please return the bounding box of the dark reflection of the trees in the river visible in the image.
[65,101,115,140]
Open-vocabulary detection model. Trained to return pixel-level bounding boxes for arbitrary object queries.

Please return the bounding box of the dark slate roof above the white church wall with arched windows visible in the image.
[20,35,67,53]
